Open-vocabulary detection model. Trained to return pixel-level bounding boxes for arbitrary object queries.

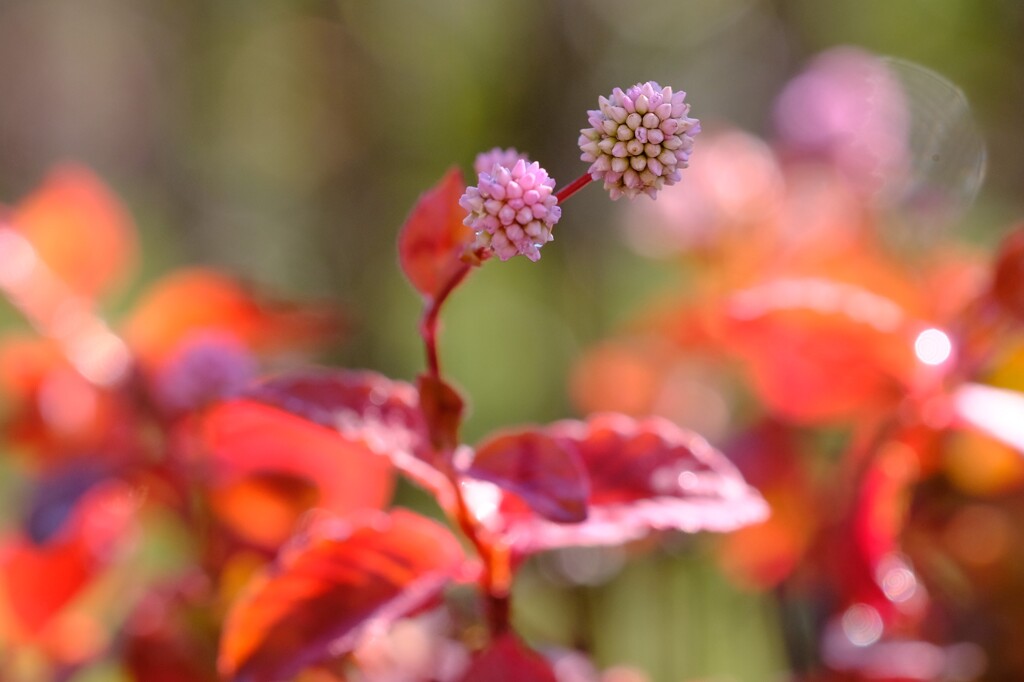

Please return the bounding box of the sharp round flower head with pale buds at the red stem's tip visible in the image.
[580,81,700,199]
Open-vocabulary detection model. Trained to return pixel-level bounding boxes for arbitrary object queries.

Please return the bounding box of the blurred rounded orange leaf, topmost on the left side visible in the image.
[11,164,136,298]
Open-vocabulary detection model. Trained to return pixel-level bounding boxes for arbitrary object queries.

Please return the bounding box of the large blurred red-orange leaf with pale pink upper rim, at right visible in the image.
[720,276,916,424]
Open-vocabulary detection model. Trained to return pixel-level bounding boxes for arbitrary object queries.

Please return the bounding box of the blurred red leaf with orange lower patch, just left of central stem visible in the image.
[197,399,393,548]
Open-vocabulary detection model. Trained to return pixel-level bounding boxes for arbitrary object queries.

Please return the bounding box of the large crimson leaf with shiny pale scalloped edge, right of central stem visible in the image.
[467,414,768,553]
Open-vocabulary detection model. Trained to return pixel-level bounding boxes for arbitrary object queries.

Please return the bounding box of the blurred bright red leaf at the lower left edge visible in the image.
[0,481,138,636]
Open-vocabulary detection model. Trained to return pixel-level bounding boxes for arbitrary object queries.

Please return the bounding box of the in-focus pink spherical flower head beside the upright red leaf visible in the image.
[459,159,562,261]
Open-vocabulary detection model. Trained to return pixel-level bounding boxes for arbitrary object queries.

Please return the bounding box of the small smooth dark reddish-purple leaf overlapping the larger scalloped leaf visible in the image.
[466,431,590,523]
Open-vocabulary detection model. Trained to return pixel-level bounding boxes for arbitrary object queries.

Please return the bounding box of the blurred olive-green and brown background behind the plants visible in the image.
[0,0,1024,682]
